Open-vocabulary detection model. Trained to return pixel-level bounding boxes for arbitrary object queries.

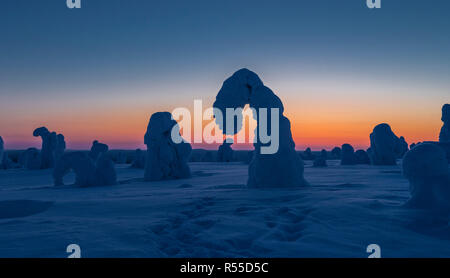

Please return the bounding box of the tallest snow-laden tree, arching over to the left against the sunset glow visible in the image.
[213,69,307,187]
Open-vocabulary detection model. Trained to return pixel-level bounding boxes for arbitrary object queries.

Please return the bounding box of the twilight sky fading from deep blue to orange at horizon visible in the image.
[0,0,450,150]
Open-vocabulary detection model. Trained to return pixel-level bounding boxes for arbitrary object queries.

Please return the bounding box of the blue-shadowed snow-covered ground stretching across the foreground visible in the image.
[0,161,450,257]
